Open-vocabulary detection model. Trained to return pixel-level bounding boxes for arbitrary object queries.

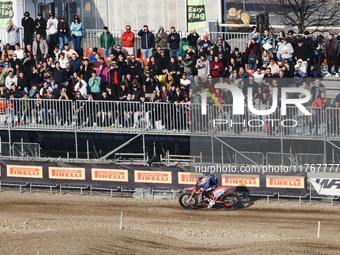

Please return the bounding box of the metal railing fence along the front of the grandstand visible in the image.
[0,99,340,140]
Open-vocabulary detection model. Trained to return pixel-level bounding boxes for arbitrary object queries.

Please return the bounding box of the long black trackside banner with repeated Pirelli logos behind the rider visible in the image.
[0,161,307,195]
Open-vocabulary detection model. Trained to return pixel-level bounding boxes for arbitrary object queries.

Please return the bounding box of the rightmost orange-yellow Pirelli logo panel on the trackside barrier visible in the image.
[266,175,305,189]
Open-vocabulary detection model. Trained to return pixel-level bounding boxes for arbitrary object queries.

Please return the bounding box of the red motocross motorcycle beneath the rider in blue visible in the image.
[179,178,241,210]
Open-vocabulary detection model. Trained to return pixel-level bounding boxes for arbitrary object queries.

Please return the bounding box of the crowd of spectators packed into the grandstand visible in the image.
[0,12,340,133]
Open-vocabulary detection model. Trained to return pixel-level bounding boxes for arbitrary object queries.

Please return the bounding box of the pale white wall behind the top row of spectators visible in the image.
[18,0,221,31]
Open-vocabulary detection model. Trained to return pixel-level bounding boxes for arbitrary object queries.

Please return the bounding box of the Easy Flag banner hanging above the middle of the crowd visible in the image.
[187,0,206,31]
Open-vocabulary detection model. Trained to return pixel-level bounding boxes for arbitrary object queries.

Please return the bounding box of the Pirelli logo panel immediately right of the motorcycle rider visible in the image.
[222,174,260,188]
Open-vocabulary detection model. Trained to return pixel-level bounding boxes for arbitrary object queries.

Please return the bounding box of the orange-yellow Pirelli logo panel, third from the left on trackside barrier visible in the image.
[91,168,129,182]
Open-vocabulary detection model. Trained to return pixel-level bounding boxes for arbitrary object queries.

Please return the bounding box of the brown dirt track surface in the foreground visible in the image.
[0,191,340,255]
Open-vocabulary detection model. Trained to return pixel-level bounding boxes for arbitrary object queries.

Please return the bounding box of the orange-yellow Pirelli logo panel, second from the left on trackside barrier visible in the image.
[48,167,86,180]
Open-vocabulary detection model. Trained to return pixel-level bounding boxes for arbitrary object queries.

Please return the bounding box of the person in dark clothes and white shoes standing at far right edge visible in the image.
[325,33,340,77]
